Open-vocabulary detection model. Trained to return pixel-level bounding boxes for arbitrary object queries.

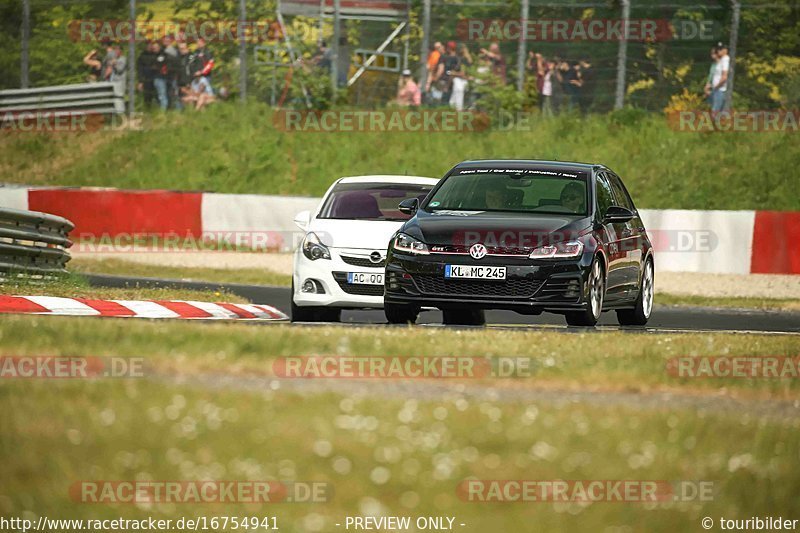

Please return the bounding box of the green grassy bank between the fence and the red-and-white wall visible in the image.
[0,103,800,210]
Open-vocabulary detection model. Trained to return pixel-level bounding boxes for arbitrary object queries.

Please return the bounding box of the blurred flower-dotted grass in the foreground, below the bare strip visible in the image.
[0,380,800,532]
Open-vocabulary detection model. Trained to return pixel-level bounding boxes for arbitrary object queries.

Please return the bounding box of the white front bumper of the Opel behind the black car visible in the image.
[292,248,385,309]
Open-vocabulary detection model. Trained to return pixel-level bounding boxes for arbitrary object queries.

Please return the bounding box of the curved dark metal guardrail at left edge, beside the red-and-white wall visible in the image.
[0,208,75,274]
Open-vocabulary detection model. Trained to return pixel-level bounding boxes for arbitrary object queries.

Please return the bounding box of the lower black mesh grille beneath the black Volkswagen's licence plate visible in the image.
[413,274,542,299]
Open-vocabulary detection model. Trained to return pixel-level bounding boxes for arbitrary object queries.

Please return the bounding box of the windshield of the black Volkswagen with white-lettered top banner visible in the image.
[425,169,589,216]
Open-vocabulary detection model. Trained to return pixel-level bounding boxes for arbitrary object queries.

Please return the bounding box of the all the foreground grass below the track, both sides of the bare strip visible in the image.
[0,316,800,532]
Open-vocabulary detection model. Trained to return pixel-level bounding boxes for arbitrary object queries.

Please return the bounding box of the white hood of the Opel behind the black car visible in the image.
[308,219,403,251]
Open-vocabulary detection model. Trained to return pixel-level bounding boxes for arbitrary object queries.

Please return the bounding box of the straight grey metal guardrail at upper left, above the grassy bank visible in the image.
[0,82,125,114]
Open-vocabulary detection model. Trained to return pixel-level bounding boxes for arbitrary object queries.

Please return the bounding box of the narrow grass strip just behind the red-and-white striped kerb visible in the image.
[0,274,248,303]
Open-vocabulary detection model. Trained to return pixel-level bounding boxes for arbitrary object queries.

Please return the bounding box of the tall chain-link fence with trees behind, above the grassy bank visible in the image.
[6,0,800,112]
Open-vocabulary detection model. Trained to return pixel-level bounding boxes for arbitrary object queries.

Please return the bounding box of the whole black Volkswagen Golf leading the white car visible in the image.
[384,160,654,326]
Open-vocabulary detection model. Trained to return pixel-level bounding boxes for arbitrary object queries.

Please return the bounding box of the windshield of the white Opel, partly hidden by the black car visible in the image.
[318,183,433,221]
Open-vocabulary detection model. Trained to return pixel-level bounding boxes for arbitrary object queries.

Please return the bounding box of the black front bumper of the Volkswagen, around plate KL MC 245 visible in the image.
[385,252,591,314]
